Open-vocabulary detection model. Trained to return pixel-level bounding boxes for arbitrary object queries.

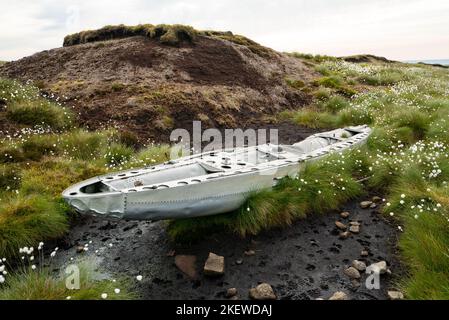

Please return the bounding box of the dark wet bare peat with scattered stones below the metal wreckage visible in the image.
[52,199,401,299]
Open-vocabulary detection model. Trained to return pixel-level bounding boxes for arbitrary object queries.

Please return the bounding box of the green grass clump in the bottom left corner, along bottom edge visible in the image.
[0,262,137,300]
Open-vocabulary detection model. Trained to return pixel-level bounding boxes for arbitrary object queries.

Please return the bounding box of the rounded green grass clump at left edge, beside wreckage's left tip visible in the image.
[0,195,68,257]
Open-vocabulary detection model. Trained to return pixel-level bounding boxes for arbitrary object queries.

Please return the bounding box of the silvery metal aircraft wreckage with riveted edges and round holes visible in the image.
[63,126,371,220]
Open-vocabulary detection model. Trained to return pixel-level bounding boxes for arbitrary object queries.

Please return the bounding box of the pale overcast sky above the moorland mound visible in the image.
[0,0,449,60]
